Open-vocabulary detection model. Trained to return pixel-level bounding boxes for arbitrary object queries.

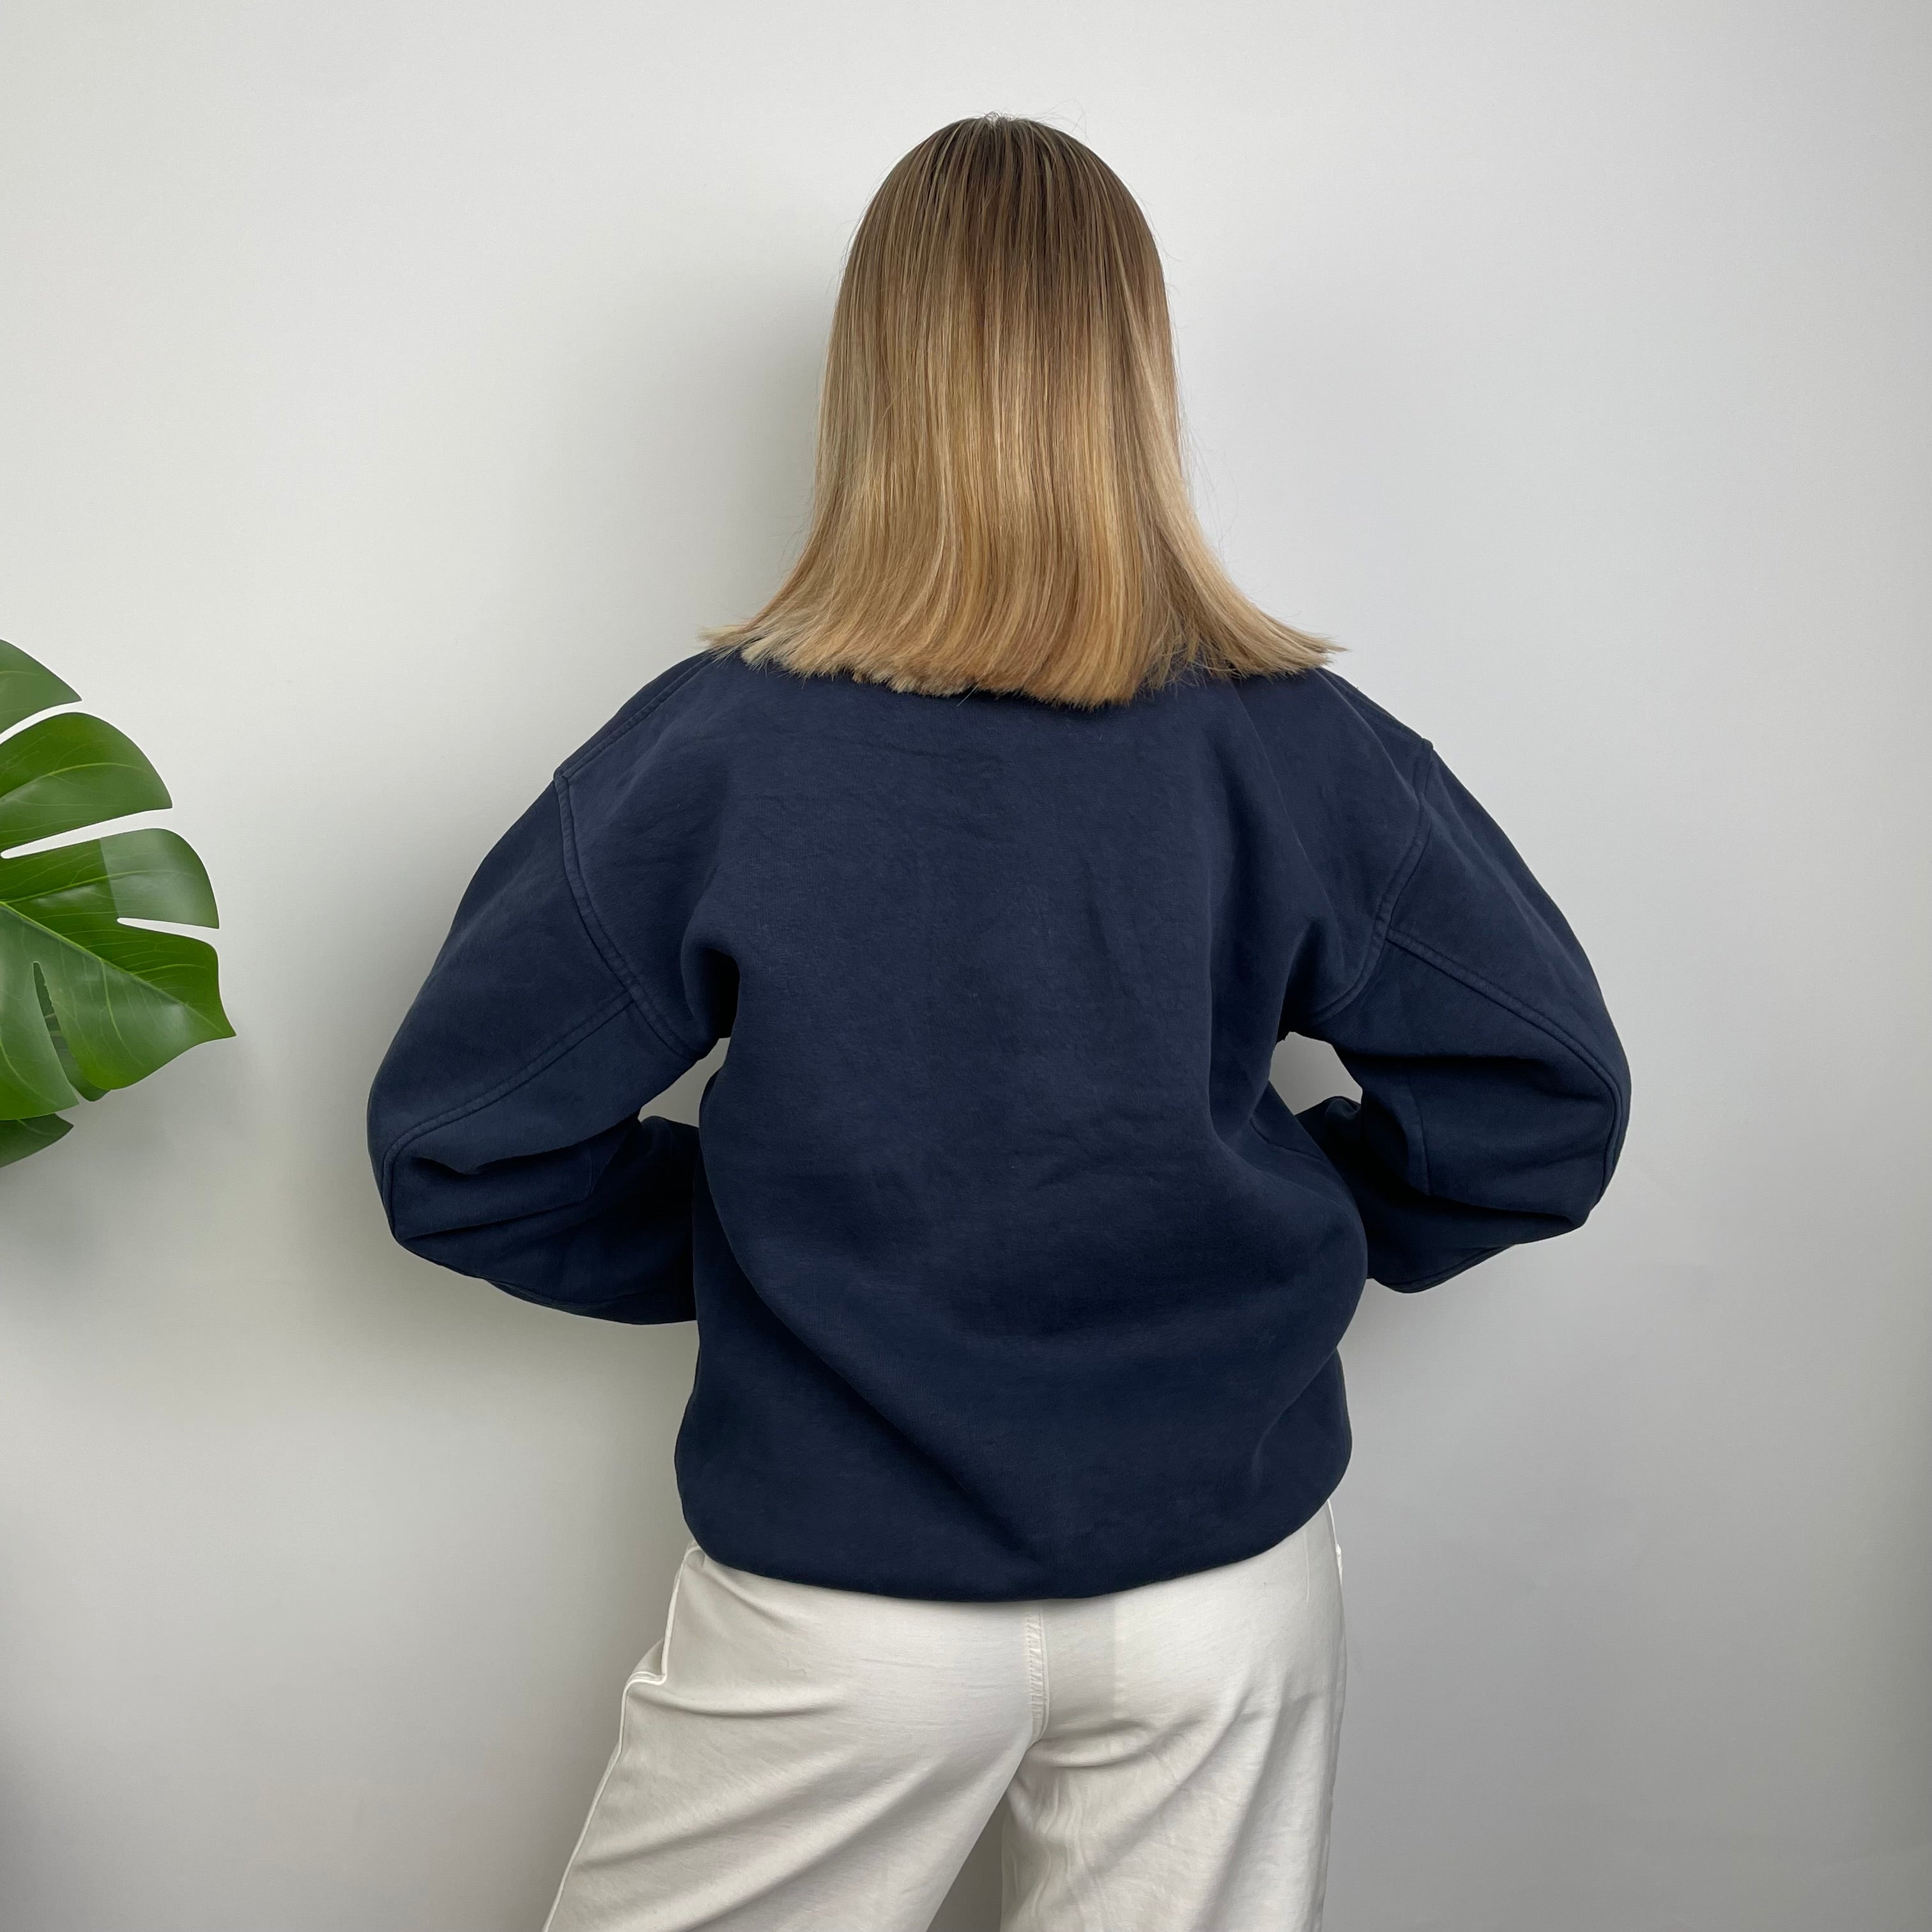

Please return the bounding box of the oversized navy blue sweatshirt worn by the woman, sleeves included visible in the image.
[369,653,1629,1600]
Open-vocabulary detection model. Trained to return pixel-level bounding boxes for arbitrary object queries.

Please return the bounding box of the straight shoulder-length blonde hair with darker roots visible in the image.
[705,114,1335,705]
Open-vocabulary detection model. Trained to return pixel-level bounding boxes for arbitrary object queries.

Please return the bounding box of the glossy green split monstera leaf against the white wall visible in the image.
[0,643,234,1167]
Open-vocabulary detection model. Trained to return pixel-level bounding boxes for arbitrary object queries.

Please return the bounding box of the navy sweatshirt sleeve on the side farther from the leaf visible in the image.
[1298,747,1629,1291]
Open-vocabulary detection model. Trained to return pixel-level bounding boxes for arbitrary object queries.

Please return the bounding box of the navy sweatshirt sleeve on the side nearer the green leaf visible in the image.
[369,785,711,1321]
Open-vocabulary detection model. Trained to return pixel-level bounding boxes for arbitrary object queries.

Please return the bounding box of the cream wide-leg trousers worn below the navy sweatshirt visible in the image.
[545,1507,1345,1932]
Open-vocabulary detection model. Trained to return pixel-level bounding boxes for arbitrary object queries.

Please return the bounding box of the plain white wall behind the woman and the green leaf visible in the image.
[0,0,1932,1932]
